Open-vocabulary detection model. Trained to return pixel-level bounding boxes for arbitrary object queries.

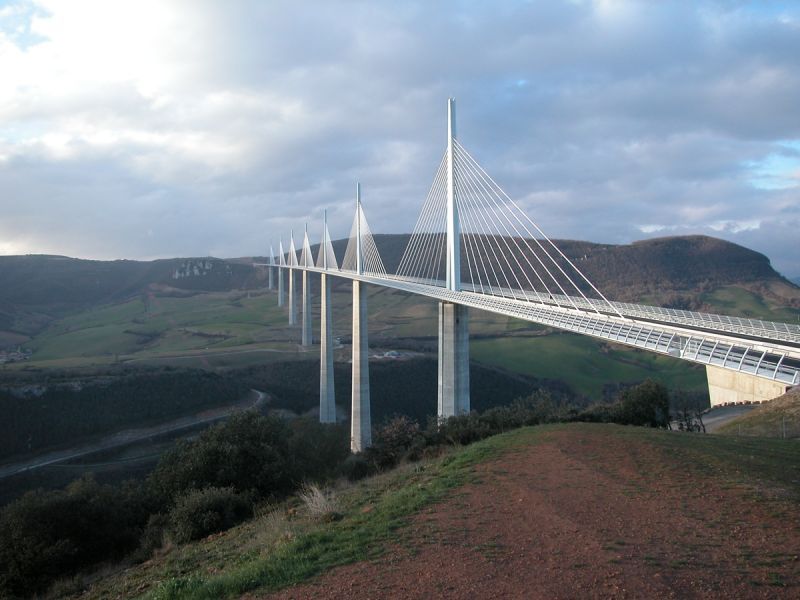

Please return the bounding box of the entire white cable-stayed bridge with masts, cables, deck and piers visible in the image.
[263,99,800,452]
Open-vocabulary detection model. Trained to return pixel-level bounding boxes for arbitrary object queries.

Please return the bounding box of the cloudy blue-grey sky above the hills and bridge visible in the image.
[0,0,800,276]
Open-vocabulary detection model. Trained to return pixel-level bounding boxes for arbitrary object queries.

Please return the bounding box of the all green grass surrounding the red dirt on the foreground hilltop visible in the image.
[75,423,800,599]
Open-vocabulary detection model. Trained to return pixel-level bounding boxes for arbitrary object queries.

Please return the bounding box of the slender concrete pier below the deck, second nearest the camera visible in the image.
[350,281,372,452]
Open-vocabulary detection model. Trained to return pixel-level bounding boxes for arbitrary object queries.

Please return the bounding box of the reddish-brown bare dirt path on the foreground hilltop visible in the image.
[275,431,800,599]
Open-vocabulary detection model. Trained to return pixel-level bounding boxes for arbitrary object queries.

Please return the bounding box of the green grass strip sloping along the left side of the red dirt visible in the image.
[81,428,545,599]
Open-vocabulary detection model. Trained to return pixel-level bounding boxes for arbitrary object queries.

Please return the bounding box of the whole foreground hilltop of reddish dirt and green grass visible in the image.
[76,424,800,598]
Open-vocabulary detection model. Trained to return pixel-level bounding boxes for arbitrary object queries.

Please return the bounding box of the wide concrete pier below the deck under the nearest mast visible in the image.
[438,302,469,419]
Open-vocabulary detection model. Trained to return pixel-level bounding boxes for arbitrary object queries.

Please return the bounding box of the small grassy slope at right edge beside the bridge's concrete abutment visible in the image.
[718,387,800,438]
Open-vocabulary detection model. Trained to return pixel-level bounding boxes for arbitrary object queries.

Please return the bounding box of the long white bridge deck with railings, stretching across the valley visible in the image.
[283,266,800,385]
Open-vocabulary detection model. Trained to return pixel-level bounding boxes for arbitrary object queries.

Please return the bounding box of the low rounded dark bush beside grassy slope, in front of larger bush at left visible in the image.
[168,487,247,544]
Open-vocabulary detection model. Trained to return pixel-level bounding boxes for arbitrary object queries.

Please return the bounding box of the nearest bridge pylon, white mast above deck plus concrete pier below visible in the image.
[439,98,469,418]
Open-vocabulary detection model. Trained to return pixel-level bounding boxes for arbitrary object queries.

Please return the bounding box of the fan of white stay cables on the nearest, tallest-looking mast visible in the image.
[397,140,621,316]
